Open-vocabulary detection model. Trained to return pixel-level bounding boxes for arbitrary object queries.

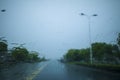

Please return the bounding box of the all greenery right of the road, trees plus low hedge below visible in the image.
[61,33,120,72]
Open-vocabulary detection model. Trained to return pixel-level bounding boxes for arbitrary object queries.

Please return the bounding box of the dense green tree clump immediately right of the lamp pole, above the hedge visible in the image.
[92,42,120,63]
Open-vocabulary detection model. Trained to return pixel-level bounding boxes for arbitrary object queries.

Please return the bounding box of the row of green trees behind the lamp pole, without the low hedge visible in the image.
[64,42,120,64]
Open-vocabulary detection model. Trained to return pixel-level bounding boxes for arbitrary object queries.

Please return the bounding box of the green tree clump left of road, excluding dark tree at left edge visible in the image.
[11,47,46,62]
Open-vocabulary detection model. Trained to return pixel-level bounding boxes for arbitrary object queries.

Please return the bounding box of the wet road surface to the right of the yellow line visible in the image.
[33,61,120,80]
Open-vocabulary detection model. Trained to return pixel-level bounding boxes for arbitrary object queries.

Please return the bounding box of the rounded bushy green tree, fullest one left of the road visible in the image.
[12,47,29,61]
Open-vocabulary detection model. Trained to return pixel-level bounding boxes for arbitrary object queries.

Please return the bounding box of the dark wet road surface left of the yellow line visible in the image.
[0,62,46,80]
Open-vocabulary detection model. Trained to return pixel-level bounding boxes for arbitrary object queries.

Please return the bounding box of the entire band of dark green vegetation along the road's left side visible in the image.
[0,40,46,67]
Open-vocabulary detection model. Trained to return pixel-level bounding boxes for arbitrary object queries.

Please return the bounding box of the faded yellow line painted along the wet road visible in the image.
[25,63,48,80]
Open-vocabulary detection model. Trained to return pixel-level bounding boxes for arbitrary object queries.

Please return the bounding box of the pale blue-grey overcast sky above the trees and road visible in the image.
[0,0,120,59]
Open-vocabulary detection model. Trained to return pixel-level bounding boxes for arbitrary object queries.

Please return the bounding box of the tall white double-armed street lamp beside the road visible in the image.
[80,13,98,64]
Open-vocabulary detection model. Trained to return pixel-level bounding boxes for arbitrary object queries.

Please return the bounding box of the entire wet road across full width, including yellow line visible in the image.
[0,61,120,80]
